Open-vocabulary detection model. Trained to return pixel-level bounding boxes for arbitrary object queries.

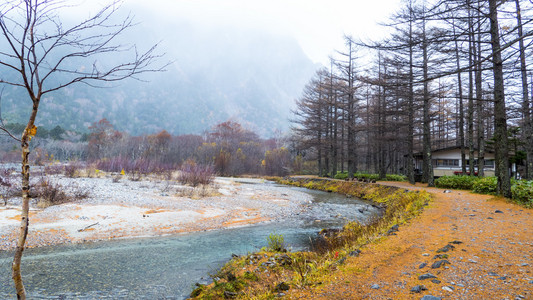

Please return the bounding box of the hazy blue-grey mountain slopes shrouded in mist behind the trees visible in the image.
[2,9,317,136]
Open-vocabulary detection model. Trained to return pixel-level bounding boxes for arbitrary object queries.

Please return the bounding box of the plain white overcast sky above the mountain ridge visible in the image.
[125,0,400,65]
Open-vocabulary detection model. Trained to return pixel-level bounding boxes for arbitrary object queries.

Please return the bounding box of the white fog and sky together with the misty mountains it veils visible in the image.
[2,0,399,136]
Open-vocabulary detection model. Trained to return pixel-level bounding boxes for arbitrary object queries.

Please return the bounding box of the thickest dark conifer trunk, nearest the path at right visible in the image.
[489,0,511,197]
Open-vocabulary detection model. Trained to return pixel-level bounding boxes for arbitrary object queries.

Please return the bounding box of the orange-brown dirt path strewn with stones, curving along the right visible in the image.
[288,182,533,300]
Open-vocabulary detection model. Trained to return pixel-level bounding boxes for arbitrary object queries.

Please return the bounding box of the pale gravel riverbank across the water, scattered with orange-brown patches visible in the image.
[0,175,311,250]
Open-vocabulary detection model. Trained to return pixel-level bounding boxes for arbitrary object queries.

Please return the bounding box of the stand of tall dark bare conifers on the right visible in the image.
[293,0,533,196]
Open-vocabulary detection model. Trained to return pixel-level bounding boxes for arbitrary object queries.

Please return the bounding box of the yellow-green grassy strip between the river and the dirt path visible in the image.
[191,178,431,299]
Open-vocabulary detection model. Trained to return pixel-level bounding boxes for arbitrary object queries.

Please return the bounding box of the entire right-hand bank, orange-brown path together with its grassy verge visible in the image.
[189,182,533,300]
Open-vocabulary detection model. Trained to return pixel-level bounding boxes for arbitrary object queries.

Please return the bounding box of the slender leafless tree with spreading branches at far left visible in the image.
[0,0,164,299]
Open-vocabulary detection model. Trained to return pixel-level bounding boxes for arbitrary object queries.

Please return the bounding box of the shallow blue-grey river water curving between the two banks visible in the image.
[0,182,379,299]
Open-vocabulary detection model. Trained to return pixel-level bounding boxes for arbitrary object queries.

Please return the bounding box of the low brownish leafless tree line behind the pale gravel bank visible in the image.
[0,119,294,176]
